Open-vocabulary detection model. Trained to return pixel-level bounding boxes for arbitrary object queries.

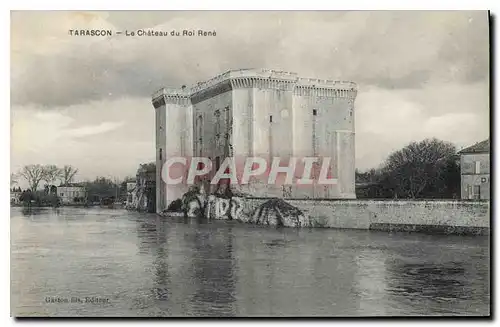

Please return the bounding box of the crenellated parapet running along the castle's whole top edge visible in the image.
[153,69,357,108]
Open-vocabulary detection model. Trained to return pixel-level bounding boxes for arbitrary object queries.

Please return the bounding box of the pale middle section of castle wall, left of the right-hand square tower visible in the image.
[231,77,294,196]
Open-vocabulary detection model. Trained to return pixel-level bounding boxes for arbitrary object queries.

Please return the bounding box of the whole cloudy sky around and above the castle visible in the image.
[10,11,489,187]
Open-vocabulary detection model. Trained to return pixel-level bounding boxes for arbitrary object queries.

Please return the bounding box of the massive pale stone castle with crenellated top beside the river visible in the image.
[152,69,357,210]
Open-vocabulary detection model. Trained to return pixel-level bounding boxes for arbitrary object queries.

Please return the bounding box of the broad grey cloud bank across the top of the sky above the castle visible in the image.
[12,12,489,105]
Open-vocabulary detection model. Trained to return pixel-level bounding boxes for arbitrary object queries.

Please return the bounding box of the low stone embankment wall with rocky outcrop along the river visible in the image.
[162,196,490,235]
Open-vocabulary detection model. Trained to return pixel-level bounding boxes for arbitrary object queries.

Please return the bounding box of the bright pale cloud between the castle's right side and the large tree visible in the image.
[355,84,489,170]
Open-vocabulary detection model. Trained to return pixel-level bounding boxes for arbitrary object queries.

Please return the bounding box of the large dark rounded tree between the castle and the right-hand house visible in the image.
[381,138,460,199]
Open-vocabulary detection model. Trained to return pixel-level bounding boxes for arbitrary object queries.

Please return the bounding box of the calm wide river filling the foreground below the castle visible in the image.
[10,208,490,317]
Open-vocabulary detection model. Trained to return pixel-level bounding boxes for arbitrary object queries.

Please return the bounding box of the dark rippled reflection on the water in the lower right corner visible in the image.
[386,247,489,315]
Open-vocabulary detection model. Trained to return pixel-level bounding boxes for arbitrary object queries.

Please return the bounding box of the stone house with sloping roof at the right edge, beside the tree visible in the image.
[458,139,490,200]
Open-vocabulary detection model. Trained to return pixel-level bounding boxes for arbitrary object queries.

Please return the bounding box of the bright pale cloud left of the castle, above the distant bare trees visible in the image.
[11,98,155,178]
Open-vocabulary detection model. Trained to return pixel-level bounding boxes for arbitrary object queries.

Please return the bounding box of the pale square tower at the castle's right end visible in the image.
[293,78,357,199]
